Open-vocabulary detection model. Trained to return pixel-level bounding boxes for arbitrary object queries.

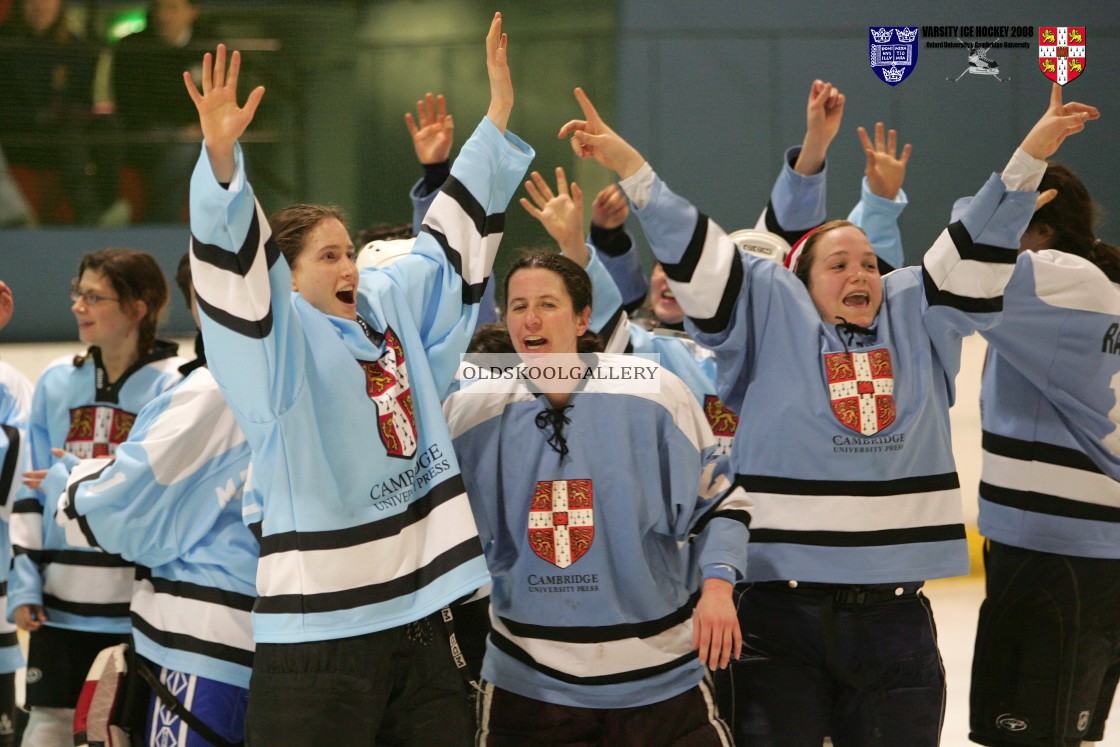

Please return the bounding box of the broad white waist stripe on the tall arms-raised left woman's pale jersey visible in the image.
[256,493,478,597]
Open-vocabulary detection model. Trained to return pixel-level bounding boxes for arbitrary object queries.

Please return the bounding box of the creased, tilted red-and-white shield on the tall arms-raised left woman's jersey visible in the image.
[358,329,419,459]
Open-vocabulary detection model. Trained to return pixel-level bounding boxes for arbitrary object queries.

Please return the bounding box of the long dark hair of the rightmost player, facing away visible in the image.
[1029,164,1120,282]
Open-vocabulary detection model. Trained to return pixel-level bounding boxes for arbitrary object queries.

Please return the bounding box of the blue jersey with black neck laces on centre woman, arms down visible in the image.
[445,355,748,708]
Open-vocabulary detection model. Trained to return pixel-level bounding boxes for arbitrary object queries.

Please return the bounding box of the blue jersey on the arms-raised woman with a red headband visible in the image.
[623,161,1045,583]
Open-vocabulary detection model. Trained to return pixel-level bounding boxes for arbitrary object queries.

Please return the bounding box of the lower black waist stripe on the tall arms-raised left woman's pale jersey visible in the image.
[253,538,483,615]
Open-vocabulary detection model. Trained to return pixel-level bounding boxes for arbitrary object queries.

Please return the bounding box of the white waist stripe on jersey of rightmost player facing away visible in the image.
[981,451,1120,507]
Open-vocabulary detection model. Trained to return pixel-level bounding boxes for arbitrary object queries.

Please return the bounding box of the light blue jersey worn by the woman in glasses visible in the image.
[8,340,185,633]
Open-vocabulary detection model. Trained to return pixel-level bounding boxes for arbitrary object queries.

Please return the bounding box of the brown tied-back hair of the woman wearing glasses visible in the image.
[74,249,168,366]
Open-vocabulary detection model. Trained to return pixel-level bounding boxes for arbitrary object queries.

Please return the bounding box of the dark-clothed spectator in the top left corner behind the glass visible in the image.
[0,0,127,223]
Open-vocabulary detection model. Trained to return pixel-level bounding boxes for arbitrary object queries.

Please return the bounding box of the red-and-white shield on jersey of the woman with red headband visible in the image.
[824,348,895,436]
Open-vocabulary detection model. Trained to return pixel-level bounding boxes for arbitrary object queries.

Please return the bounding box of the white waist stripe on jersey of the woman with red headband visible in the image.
[750,489,963,532]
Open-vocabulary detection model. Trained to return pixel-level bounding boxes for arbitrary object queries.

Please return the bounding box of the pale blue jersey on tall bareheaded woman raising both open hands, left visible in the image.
[190,120,533,643]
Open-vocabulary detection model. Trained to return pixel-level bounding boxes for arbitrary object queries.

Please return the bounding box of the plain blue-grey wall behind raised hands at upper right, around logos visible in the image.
[618,0,1120,268]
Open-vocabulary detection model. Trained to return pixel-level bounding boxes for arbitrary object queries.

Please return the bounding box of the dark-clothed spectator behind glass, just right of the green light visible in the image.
[112,0,200,223]
